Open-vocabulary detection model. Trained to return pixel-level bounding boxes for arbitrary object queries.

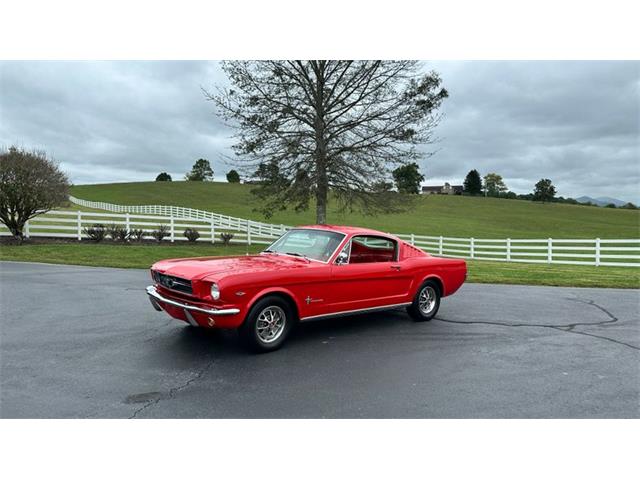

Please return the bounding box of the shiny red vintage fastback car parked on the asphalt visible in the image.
[147,225,467,351]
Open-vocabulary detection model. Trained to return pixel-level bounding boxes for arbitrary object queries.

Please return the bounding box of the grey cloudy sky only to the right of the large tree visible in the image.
[425,62,640,202]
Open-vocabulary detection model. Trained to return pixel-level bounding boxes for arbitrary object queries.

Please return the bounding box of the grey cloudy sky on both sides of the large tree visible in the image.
[0,61,640,203]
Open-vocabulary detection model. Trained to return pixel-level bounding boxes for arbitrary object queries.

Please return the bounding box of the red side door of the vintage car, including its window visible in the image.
[327,235,411,313]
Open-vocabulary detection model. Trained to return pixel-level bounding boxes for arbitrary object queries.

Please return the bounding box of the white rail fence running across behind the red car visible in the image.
[0,207,640,267]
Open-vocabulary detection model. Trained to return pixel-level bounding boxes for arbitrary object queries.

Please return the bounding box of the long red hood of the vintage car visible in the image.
[152,254,317,280]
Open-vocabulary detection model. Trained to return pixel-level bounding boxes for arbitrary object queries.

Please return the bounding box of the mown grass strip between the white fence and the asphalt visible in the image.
[0,243,640,288]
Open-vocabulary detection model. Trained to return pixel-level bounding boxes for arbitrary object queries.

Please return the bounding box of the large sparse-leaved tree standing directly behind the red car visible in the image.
[205,61,447,224]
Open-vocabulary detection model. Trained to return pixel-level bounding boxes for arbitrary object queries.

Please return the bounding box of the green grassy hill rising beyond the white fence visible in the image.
[71,182,640,238]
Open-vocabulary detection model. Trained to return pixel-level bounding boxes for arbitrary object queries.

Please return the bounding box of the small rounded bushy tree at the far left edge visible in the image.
[0,147,69,241]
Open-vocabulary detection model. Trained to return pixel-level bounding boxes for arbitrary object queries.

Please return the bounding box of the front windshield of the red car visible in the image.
[264,229,344,262]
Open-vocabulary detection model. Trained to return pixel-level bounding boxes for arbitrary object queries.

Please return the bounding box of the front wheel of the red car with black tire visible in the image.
[238,296,296,353]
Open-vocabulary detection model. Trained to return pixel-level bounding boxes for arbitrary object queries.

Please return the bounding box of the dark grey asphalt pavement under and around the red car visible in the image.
[0,262,640,418]
